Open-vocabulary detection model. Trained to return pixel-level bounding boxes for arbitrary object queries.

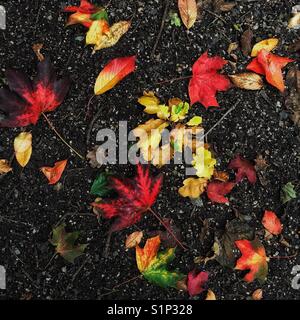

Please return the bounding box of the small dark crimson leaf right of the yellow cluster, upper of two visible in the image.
[228,154,256,184]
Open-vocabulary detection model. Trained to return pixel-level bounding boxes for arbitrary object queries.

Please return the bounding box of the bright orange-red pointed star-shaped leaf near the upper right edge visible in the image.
[247,49,294,92]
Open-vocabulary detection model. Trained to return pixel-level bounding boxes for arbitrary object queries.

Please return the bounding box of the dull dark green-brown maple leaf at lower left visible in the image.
[49,224,87,263]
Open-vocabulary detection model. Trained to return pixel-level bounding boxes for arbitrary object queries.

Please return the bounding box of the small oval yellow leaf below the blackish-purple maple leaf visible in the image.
[14,132,32,168]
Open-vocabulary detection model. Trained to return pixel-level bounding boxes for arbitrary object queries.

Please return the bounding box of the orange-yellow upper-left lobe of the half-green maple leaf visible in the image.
[136,236,160,272]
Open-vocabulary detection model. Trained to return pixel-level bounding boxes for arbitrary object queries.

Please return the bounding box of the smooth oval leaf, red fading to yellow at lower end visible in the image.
[94,56,136,95]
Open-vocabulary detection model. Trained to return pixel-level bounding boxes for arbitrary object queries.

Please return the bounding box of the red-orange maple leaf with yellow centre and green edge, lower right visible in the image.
[235,239,268,282]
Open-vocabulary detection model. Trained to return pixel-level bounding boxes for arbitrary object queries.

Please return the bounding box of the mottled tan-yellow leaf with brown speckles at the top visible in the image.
[94,20,131,52]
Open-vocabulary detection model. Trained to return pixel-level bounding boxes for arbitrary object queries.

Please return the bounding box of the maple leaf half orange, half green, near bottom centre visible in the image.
[136,236,185,288]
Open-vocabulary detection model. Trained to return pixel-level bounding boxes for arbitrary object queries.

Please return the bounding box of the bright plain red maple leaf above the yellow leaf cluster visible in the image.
[189,52,230,108]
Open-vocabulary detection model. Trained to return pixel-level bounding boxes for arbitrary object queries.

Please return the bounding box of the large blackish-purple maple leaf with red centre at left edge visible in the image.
[0,58,70,127]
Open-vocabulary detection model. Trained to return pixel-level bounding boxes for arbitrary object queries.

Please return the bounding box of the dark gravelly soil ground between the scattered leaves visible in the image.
[0,0,300,300]
